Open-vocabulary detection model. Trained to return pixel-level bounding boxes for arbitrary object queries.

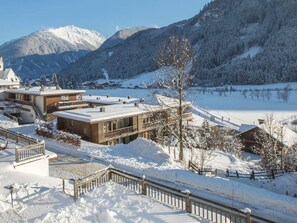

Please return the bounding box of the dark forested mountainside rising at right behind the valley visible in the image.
[61,0,297,86]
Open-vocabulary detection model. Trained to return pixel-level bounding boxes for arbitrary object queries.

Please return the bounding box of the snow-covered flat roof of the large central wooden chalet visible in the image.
[53,104,160,123]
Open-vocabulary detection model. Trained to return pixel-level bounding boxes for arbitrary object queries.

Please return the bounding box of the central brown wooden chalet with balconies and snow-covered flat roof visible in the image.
[54,103,192,145]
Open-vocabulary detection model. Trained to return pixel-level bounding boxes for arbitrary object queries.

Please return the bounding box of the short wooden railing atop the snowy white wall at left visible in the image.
[15,142,45,163]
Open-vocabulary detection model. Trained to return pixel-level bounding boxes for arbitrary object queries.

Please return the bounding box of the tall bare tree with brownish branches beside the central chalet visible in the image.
[156,36,193,161]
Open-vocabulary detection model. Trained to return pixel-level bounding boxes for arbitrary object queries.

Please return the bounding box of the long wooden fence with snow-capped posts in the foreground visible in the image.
[74,168,273,223]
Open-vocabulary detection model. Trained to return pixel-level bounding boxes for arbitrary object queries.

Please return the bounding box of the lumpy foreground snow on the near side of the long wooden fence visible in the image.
[0,179,207,223]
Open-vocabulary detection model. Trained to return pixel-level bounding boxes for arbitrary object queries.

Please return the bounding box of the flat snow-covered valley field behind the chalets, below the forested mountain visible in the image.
[87,77,297,124]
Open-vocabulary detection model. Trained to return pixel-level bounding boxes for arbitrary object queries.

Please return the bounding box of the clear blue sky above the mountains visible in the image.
[0,0,210,44]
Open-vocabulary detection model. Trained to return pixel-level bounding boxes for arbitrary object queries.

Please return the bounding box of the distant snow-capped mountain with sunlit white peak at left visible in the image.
[0,26,106,78]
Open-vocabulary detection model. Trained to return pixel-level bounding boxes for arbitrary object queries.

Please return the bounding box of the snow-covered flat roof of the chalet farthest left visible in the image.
[5,87,86,95]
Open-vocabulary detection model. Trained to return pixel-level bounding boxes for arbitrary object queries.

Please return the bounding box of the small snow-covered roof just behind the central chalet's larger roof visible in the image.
[83,95,139,105]
